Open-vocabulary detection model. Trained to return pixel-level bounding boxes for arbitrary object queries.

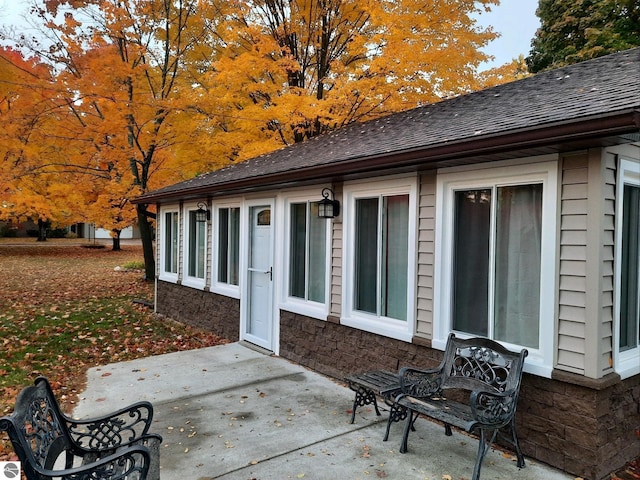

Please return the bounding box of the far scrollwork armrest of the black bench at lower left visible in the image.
[65,402,153,451]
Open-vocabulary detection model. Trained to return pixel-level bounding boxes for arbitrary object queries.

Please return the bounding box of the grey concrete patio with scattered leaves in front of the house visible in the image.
[74,343,574,480]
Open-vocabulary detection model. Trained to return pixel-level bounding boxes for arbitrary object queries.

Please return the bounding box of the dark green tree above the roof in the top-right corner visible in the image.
[526,0,640,73]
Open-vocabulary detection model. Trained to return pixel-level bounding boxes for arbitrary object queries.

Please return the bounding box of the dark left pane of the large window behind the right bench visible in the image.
[452,189,491,336]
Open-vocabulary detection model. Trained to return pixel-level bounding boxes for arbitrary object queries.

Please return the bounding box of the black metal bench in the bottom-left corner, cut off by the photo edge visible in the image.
[0,377,162,480]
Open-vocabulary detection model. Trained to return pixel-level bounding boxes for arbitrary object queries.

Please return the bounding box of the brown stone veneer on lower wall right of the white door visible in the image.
[280,312,640,480]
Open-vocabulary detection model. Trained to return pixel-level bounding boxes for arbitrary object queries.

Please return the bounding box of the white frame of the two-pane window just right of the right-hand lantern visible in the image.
[340,176,418,342]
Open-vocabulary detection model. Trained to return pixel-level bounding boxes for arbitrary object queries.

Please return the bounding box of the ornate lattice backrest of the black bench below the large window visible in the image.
[442,336,526,392]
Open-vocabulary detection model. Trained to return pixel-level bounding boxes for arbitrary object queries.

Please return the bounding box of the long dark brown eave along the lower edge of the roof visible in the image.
[132,108,640,204]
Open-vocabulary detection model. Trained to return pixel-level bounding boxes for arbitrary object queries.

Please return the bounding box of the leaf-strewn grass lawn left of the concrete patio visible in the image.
[0,238,226,460]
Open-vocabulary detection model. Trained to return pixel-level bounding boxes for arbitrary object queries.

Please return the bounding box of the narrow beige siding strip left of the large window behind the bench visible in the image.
[416,173,436,339]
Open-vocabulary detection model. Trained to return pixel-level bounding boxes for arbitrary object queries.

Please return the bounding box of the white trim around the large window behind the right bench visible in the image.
[432,157,558,378]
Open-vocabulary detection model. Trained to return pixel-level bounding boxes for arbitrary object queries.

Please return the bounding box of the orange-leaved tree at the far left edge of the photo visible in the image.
[0,48,87,240]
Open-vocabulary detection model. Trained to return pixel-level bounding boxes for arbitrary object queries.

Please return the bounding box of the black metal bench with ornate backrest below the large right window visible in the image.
[396,334,527,480]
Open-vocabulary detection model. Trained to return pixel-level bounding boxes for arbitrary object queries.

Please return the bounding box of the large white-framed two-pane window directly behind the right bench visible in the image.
[433,161,557,376]
